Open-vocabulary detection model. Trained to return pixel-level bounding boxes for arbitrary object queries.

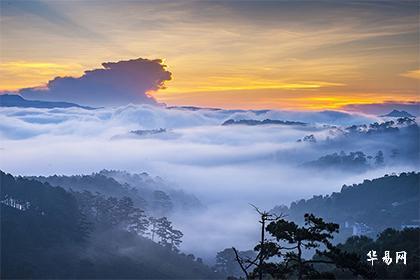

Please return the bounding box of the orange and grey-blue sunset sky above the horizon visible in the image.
[0,0,420,110]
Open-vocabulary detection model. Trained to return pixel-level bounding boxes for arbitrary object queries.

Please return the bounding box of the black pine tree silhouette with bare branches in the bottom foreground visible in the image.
[233,207,374,279]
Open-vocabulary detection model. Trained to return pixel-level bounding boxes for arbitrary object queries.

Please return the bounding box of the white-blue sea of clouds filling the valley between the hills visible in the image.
[0,105,418,260]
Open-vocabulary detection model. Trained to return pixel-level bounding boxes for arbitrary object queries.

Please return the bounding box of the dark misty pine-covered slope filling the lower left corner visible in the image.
[0,171,218,279]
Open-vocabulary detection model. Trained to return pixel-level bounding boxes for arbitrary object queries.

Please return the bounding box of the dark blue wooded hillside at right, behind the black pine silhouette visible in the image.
[272,172,420,240]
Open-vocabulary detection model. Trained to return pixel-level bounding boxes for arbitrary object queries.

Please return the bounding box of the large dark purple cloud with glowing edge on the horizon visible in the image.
[19,58,171,106]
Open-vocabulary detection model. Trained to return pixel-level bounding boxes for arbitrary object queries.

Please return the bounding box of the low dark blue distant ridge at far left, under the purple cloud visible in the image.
[0,94,95,110]
